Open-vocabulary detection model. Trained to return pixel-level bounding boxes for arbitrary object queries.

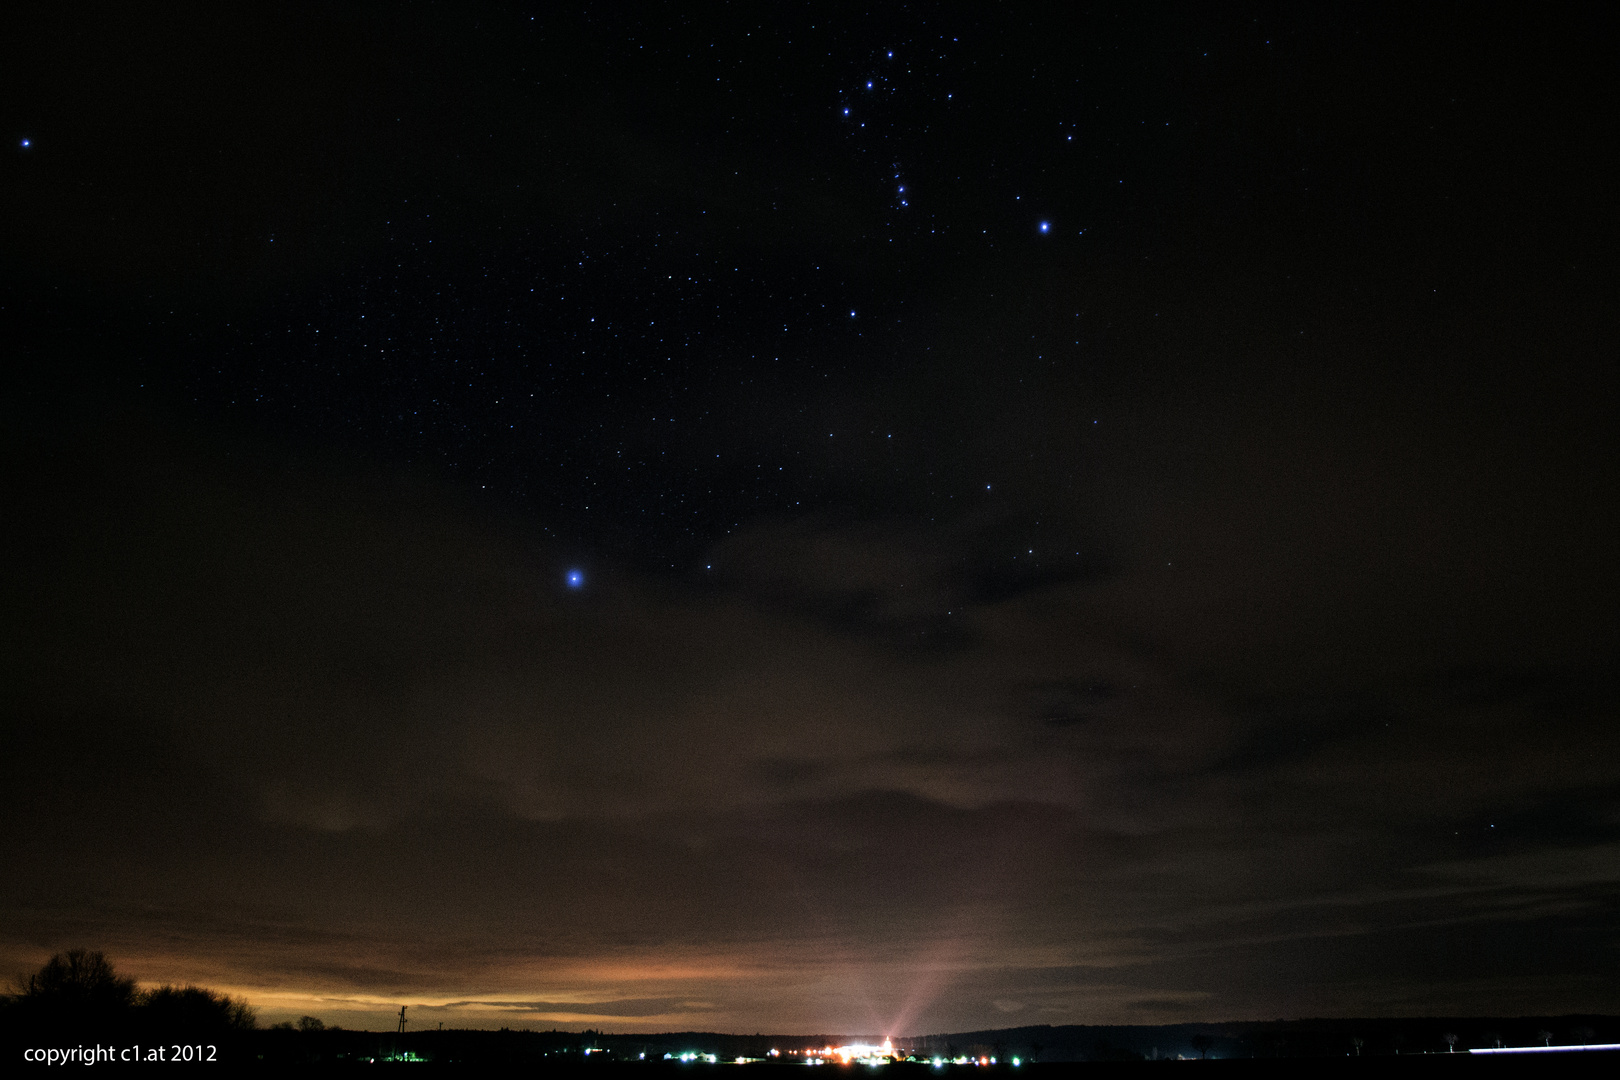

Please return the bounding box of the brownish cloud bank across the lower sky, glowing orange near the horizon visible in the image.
[6,401,1617,1027]
